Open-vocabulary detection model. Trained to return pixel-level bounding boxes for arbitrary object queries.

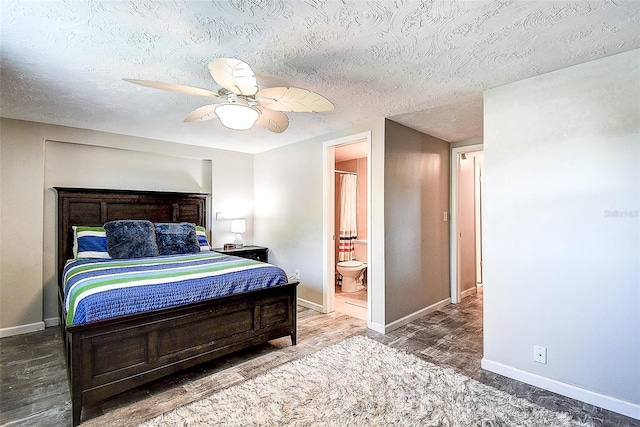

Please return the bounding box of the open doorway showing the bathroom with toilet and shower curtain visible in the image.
[325,135,370,321]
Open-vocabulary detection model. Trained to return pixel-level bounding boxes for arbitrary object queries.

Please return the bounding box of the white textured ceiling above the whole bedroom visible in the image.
[0,0,640,153]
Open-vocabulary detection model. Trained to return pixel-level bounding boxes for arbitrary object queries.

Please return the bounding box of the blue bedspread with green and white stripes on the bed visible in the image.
[63,252,287,325]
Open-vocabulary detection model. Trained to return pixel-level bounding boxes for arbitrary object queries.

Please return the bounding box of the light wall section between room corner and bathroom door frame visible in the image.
[254,135,324,305]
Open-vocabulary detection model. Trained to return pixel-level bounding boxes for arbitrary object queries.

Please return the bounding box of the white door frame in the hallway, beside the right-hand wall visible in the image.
[449,144,484,304]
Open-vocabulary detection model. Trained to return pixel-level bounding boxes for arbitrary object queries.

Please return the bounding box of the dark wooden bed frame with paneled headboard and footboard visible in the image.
[55,187,298,426]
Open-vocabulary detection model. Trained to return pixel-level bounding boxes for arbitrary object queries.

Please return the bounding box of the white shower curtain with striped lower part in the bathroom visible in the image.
[338,174,358,261]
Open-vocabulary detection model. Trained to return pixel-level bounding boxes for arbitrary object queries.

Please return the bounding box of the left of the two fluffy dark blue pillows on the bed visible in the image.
[104,219,158,258]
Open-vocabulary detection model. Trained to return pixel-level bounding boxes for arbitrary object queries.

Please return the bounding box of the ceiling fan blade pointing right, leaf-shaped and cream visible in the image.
[256,87,334,113]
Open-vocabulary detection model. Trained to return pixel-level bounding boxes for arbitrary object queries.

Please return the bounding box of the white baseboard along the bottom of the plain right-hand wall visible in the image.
[480,358,640,419]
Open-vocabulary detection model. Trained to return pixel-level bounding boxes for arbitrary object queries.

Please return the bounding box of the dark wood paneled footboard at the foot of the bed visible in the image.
[66,282,298,426]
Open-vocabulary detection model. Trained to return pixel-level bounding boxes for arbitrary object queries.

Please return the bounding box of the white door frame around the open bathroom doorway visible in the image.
[322,131,375,324]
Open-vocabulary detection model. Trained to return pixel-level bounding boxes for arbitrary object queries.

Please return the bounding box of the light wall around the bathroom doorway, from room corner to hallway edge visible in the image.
[254,120,385,330]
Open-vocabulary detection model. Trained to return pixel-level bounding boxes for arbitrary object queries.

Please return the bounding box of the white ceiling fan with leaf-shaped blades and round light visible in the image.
[123,58,334,133]
